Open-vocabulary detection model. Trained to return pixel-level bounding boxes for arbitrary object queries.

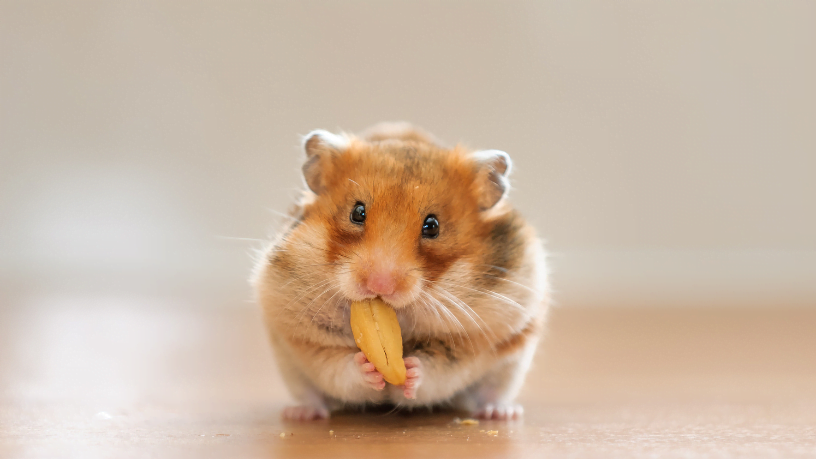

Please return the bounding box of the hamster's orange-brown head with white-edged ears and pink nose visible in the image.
[295,131,511,309]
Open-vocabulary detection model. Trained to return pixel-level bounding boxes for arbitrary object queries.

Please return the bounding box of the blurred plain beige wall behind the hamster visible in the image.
[0,0,816,304]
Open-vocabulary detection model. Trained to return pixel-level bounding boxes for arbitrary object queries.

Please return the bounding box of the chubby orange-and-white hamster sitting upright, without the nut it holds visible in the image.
[252,123,549,420]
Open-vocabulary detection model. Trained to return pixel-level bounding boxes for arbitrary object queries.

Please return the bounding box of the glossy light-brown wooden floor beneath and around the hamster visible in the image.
[0,296,816,459]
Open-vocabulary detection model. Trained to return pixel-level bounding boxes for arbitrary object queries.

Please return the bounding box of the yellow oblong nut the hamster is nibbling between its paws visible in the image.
[351,298,405,386]
